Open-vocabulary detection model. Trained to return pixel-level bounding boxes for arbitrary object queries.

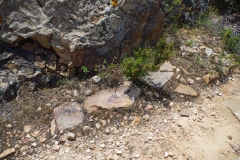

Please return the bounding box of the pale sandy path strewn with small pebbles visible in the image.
[20,76,240,160]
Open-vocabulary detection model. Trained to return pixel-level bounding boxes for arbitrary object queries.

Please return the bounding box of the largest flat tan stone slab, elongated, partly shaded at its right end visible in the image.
[84,82,140,113]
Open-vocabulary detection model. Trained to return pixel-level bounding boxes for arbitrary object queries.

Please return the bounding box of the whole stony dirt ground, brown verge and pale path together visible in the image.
[0,13,240,160]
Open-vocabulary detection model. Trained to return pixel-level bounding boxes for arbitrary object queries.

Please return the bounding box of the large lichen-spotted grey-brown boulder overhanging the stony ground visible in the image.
[0,0,216,75]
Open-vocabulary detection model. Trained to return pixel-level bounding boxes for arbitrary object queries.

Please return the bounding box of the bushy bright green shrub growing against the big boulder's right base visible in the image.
[120,38,174,80]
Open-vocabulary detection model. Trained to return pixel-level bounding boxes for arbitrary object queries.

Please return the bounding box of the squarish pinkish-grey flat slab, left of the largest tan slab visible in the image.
[53,102,84,130]
